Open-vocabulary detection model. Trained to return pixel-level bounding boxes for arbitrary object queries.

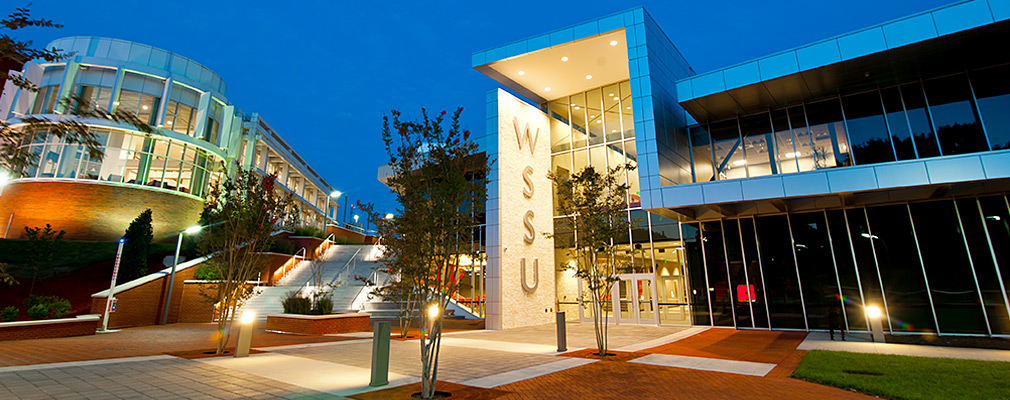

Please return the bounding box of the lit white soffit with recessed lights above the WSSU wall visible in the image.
[475,28,629,103]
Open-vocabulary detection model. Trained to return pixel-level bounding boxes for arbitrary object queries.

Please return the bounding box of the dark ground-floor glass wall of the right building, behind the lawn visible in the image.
[670,195,1010,335]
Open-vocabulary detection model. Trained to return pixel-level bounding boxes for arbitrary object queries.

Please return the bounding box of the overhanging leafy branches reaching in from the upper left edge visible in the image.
[0,7,155,178]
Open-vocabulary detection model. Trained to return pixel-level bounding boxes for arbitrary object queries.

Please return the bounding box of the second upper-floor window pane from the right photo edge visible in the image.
[924,74,989,156]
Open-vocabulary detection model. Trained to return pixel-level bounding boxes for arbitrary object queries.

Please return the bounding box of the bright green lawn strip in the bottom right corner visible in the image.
[793,351,1010,399]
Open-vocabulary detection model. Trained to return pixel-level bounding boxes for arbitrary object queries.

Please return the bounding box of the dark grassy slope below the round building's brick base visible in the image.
[0,239,176,278]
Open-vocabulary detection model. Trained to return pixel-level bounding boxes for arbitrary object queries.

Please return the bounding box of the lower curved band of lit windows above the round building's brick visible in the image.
[22,126,223,197]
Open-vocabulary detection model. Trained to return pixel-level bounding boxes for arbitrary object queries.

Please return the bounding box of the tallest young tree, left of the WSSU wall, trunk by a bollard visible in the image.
[363,107,490,399]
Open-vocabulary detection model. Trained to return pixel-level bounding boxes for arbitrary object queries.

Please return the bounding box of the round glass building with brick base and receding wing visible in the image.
[0,36,336,239]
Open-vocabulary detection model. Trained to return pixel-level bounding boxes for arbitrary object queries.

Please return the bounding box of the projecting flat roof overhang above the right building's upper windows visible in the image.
[677,8,1010,121]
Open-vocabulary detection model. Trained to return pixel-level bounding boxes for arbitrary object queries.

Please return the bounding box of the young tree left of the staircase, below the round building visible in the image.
[200,168,291,354]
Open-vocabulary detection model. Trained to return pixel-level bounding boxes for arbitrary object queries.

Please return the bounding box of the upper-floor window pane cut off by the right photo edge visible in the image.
[971,65,1010,151]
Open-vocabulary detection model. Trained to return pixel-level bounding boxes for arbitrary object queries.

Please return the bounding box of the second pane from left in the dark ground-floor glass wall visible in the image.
[701,221,733,326]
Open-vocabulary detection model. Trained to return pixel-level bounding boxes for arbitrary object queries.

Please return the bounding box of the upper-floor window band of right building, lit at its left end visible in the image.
[687,65,1010,182]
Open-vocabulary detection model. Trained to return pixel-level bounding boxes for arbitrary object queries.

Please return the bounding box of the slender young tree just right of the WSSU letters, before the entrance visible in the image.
[547,164,634,357]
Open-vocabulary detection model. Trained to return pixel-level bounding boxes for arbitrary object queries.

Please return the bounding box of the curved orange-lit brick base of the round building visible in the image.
[0,181,203,240]
